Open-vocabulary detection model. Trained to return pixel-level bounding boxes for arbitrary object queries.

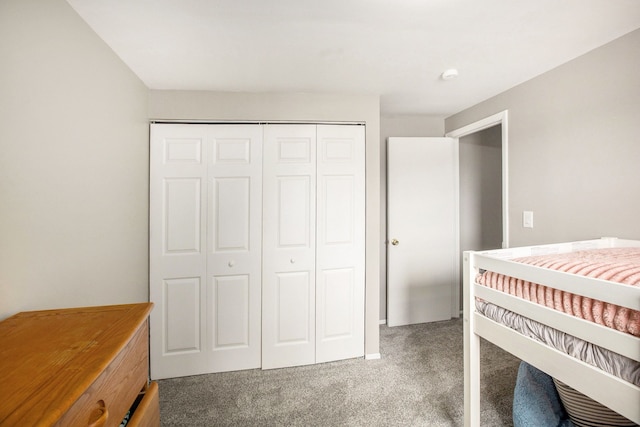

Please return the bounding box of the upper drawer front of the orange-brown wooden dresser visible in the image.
[57,321,149,427]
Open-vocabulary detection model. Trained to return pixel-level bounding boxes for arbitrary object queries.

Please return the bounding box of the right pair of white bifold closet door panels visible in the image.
[262,125,365,369]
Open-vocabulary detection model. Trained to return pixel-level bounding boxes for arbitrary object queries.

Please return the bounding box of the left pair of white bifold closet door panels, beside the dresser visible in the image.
[150,124,262,379]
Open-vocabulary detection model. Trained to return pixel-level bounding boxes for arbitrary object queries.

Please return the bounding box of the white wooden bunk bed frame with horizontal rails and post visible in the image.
[463,238,640,427]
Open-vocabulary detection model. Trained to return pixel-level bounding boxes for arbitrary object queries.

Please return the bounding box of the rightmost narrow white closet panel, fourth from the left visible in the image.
[316,125,365,363]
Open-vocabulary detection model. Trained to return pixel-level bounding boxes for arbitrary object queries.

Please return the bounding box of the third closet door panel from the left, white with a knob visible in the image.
[262,125,316,369]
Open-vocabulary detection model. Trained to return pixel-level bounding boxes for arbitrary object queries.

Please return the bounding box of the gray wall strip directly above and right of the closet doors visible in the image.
[149,90,381,356]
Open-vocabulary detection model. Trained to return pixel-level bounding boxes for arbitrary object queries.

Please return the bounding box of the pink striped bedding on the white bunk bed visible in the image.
[476,247,640,336]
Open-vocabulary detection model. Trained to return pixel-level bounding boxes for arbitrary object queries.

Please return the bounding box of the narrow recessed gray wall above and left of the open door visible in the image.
[380,115,444,323]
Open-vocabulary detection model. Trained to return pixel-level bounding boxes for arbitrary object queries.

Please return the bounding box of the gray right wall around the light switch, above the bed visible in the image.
[445,30,640,246]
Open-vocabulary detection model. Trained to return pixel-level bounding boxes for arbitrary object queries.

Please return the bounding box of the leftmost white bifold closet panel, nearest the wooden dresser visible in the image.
[149,125,207,379]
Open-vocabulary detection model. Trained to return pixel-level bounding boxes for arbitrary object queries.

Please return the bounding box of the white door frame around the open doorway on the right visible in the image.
[445,110,509,313]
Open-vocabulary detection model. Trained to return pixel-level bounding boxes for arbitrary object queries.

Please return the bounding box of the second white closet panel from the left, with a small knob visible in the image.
[207,125,262,372]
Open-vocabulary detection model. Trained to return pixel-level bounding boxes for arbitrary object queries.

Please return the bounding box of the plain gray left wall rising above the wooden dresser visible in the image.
[0,0,148,318]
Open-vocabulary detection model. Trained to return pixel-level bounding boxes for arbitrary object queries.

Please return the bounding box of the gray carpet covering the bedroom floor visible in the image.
[159,319,519,427]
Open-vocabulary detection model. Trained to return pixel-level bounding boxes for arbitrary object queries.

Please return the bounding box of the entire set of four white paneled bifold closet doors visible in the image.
[150,124,365,379]
